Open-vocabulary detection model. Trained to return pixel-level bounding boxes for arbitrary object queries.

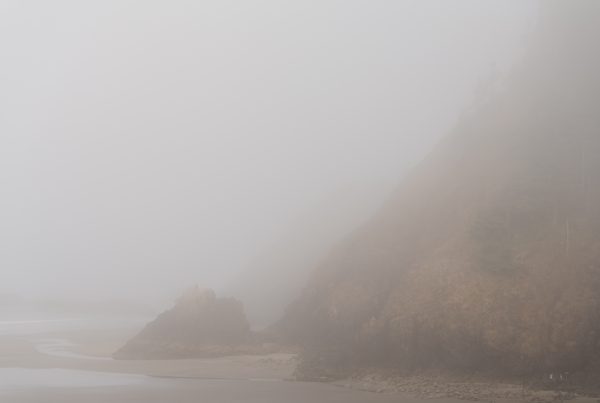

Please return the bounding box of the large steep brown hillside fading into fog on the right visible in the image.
[279,0,600,378]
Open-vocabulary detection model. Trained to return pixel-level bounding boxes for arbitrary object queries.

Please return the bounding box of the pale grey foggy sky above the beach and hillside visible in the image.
[0,0,537,299]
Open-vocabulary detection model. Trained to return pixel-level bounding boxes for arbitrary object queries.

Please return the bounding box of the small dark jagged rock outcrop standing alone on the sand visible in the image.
[114,287,253,359]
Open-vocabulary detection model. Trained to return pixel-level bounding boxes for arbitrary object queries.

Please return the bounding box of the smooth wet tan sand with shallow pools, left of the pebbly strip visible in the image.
[0,322,419,403]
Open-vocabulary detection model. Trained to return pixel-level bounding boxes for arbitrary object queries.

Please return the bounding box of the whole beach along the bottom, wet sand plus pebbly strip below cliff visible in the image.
[0,320,597,403]
